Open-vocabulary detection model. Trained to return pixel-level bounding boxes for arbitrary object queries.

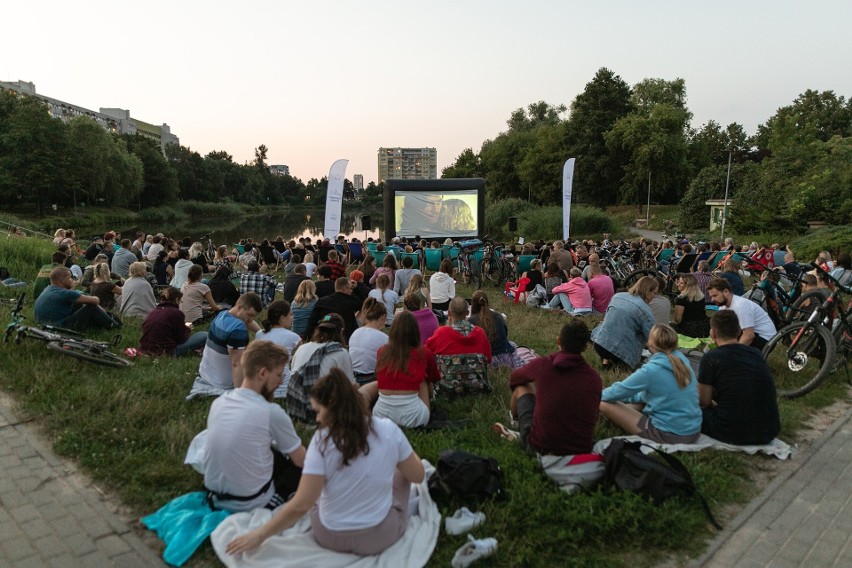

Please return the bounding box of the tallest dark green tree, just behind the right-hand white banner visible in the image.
[563,67,634,206]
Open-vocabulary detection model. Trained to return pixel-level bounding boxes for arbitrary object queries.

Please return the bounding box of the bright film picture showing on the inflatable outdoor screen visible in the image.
[394,189,479,238]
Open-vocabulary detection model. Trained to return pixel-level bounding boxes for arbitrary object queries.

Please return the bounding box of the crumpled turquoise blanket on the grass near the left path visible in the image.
[142,491,230,566]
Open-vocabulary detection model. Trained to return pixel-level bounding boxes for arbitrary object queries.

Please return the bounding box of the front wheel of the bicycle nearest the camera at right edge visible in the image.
[763,322,836,398]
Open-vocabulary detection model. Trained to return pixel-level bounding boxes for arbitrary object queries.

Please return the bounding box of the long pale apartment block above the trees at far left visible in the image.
[0,81,180,154]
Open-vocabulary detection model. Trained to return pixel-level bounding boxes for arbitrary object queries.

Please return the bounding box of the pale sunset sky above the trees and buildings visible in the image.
[0,0,852,183]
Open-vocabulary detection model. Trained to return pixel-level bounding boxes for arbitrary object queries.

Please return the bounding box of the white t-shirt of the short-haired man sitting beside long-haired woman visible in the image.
[204,388,302,511]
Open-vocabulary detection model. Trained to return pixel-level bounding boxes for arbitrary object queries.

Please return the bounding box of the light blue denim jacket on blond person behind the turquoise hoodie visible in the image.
[592,292,654,369]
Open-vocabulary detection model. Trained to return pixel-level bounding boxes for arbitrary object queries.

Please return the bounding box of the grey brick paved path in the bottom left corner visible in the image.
[0,392,165,568]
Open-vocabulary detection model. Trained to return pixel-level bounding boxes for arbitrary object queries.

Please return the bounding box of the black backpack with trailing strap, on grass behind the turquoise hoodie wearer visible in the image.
[603,438,722,530]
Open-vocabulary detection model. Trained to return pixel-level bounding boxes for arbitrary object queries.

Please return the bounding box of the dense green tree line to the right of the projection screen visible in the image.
[443,68,852,231]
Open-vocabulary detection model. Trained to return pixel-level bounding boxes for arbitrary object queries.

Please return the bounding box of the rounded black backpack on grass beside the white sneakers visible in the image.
[429,450,504,502]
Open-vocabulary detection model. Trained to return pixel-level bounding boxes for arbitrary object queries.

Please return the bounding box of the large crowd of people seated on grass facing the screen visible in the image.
[15,224,852,554]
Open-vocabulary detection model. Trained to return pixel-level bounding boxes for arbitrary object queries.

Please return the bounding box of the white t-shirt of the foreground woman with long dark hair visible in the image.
[302,417,413,531]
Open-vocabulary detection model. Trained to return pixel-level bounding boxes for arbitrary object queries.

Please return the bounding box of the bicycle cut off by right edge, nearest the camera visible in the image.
[763,263,852,398]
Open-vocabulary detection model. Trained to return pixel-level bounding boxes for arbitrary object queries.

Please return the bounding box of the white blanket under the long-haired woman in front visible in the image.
[210,460,441,568]
